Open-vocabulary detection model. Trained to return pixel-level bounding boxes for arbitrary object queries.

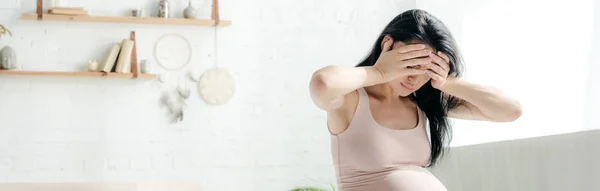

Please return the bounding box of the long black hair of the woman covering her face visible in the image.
[356,9,463,167]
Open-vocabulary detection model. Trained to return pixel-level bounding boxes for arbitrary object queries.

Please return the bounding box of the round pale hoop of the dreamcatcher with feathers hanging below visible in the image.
[154,34,192,70]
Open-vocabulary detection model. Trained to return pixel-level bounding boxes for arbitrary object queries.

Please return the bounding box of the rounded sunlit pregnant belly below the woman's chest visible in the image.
[340,166,447,191]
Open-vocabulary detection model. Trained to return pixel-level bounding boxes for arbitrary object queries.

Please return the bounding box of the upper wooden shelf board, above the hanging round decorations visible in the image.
[21,13,231,26]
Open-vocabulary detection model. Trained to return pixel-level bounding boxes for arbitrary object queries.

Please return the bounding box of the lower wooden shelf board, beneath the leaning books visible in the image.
[0,70,156,79]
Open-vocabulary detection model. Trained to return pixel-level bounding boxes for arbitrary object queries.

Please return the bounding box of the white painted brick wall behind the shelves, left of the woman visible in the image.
[0,0,415,191]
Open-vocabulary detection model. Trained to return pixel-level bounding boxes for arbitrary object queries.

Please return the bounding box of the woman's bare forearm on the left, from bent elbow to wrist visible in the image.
[311,66,384,101]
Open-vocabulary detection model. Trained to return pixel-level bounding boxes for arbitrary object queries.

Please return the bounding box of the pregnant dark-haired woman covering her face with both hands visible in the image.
[310,10,521,191]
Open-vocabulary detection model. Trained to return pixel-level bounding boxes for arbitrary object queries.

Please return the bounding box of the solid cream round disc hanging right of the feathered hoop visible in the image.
[198,67,236,105]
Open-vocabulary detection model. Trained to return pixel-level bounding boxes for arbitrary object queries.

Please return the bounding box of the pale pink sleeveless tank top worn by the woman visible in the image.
[331,88,437,191]
